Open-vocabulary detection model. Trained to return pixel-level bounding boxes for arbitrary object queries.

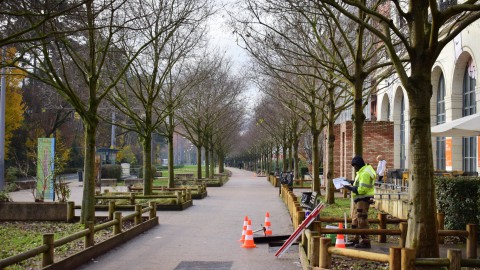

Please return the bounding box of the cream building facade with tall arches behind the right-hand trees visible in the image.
[376,22,480,174]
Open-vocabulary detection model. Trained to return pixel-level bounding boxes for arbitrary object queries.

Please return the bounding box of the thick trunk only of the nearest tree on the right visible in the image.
[406,77,439,258]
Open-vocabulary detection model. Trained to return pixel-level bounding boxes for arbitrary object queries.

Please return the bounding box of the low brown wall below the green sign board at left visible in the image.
[0,202,67,221]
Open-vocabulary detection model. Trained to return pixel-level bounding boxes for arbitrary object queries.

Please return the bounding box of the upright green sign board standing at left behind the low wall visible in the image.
[35,138,55,200]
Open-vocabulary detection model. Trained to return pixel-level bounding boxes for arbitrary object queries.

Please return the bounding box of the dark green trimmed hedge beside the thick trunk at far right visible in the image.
[435,177,480,230]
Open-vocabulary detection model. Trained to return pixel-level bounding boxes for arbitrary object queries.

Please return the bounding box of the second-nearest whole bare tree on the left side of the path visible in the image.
[108,0,209,195]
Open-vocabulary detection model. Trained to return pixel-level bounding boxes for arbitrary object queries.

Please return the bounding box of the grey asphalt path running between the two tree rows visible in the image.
[79,168,302,270]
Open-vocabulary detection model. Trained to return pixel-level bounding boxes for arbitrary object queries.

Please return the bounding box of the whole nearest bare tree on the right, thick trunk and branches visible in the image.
[318,0,480,257]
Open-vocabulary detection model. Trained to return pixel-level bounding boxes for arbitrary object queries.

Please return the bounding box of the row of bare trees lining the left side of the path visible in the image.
[0,0,248,222]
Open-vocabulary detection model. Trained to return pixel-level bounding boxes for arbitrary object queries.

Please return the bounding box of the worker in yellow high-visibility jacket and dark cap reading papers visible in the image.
[345,156,377,248]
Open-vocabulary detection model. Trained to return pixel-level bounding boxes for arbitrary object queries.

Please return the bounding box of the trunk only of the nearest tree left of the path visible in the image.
[80,121,97,224]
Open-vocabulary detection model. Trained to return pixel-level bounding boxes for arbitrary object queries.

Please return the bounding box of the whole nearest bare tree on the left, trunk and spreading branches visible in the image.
[17,0,165,223]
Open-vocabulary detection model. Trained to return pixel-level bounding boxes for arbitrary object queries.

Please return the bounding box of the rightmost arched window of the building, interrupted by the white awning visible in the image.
[462,60,477,172]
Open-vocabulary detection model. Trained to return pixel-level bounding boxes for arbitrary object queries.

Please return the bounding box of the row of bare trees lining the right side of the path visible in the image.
[227,0,480,257]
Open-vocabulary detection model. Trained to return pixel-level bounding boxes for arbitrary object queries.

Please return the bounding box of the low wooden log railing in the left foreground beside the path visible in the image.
[0,202,157,269]
